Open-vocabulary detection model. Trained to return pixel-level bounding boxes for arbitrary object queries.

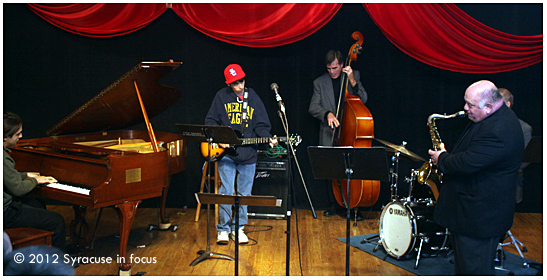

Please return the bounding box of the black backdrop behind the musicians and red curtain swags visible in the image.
[3,4,543,212]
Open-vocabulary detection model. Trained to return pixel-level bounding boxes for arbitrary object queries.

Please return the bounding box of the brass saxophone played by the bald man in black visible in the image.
[417,111,467,184]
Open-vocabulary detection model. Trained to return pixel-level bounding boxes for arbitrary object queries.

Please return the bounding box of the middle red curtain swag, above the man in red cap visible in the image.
[173,3,342,47]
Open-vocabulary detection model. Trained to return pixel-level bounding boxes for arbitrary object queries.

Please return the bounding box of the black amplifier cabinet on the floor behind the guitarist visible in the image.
[247,153,289,219]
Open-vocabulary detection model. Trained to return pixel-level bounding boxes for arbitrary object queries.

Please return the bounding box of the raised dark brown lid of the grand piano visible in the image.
[46,60,182,136]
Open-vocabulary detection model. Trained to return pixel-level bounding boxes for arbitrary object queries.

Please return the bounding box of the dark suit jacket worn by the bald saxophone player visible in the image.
[434,105,524,238]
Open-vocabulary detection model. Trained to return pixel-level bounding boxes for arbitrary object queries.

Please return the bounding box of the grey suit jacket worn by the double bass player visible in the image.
[308,70,367,146]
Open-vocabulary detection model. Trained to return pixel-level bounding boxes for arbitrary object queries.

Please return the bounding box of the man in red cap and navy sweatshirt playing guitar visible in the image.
[205,64,277,244]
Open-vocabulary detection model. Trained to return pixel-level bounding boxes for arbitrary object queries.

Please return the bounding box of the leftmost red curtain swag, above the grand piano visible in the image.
[27,4,167,37]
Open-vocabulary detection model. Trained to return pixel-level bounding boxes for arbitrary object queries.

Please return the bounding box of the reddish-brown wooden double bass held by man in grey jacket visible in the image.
[332,31,380,208]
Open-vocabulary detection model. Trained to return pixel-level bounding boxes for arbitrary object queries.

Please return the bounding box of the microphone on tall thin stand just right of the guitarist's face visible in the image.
[272,88,317,276]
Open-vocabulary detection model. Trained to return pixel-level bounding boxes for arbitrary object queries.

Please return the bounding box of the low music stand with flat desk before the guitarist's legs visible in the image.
[196,193,282,276]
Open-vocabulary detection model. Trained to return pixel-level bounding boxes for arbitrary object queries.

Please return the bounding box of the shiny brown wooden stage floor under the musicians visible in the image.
[48,206,543,276]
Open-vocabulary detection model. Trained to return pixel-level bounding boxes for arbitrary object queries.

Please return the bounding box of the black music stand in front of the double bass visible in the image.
[308,146,389,276]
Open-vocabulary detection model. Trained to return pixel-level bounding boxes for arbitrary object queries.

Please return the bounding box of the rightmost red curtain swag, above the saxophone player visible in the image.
[363,4,543,73]
